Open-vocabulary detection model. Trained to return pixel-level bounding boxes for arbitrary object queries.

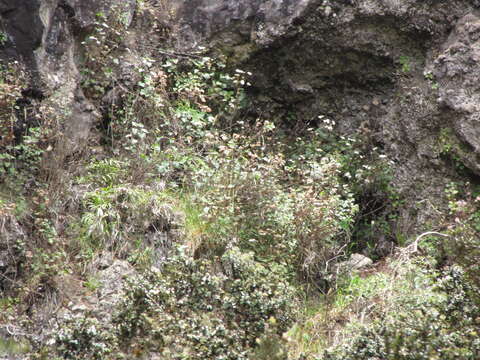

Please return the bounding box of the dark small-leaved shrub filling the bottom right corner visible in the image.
[318,267,480,360]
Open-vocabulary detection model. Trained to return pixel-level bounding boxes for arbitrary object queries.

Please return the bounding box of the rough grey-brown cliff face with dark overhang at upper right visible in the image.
[174,0,479,231]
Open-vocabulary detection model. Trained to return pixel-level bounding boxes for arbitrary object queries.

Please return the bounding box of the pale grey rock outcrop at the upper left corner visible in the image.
[0,0,136,162]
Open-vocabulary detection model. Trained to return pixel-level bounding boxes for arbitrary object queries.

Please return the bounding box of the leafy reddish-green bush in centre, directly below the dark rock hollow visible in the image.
[167,122,356,279]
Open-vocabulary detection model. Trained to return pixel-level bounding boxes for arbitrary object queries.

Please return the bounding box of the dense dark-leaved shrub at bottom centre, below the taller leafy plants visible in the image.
[115,248,295,360]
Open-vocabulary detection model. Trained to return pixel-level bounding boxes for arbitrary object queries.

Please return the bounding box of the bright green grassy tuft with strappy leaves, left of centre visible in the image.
[77,186,180,257]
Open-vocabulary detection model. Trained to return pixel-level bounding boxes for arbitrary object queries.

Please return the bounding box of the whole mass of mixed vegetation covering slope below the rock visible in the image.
[0,2,480,360]
